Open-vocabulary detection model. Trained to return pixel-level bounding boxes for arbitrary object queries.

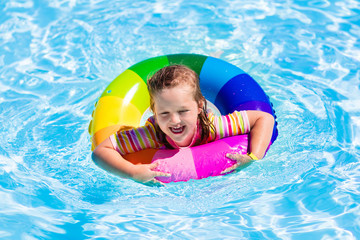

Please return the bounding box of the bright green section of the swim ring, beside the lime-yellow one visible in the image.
[129,55,169,83]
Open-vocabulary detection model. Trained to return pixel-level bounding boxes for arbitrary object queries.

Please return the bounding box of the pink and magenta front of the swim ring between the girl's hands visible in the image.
[153,135,248,183]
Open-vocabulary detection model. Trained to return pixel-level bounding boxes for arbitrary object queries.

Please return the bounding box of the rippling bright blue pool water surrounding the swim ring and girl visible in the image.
[0,0,360,239]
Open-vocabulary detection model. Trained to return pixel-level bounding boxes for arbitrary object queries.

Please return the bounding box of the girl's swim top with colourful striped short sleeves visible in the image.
[110,111,250,155]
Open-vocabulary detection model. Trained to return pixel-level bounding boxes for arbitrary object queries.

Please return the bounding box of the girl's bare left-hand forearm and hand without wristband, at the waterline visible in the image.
[92,138,170,183]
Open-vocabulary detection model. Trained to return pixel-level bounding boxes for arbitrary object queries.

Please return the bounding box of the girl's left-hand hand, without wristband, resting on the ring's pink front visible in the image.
[132,162,171,186]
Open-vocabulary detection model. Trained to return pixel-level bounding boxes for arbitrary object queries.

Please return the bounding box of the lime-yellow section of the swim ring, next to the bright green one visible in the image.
[100,69,150,112]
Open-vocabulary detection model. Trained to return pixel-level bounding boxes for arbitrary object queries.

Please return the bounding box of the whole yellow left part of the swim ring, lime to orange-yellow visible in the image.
[89,69,150,149]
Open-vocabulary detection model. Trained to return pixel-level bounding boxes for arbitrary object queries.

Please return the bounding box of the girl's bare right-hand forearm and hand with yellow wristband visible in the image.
[222,111,275,173]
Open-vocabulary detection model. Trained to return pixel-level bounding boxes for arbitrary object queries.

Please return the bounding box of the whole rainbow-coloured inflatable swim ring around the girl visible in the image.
[89,54,278,182]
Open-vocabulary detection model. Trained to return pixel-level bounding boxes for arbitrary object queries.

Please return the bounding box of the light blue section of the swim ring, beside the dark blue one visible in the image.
[199,57,244,104]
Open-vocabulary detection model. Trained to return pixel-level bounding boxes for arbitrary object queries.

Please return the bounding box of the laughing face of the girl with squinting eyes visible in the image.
[153,84,201,147]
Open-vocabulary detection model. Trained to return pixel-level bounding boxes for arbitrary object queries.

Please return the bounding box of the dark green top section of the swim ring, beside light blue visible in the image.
[167,54,207,76]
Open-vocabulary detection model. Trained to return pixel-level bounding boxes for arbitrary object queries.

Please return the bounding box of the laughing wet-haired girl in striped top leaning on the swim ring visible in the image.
[93,65,274,183]
